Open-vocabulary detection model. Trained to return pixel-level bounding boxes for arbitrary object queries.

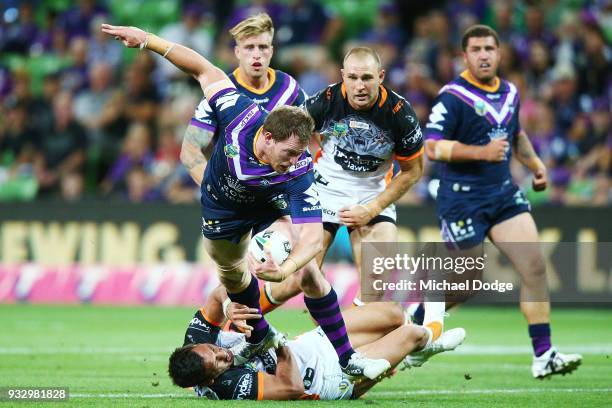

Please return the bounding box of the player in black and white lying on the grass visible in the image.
[168,287,465,400]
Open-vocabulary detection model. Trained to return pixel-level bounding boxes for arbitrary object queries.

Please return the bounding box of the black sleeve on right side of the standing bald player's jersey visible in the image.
[393,100,423,158]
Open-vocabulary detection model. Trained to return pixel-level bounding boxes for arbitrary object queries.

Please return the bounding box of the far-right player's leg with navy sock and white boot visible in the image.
[489,213,582,379]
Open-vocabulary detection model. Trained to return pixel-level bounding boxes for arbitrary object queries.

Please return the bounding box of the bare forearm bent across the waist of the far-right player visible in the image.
[425,139,510,162]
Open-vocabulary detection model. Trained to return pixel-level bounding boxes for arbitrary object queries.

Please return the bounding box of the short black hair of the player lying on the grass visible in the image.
[168,344,208,388]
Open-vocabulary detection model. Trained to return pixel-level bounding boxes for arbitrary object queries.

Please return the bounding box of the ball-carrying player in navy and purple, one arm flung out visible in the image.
[102,24,390,379]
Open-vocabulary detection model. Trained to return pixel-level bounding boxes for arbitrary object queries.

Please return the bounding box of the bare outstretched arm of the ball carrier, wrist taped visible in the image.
[101,24,231,97]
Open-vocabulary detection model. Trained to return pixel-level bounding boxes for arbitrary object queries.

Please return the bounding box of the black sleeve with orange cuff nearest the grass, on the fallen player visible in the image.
[209,366,263,400]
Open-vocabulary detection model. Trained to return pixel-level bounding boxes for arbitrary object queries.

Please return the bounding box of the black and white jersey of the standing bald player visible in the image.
[305,83,423,223]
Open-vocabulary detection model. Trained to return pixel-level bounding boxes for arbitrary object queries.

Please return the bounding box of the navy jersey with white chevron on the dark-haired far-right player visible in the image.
[425,71,521,186]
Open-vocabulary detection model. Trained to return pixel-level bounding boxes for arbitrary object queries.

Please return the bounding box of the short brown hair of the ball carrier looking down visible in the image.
[263,106,314,143]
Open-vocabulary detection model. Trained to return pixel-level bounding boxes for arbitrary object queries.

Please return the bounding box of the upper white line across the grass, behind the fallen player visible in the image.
[0,343,612,356]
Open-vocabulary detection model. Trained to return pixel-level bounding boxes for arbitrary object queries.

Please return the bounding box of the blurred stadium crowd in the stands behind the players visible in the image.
[0,0,612,206]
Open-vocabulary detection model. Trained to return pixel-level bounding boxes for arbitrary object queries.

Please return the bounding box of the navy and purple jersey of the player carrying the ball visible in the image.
[201,88,321,223]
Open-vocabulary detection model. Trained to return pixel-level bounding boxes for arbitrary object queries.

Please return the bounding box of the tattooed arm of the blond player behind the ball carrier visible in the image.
[181,125,214,186]
